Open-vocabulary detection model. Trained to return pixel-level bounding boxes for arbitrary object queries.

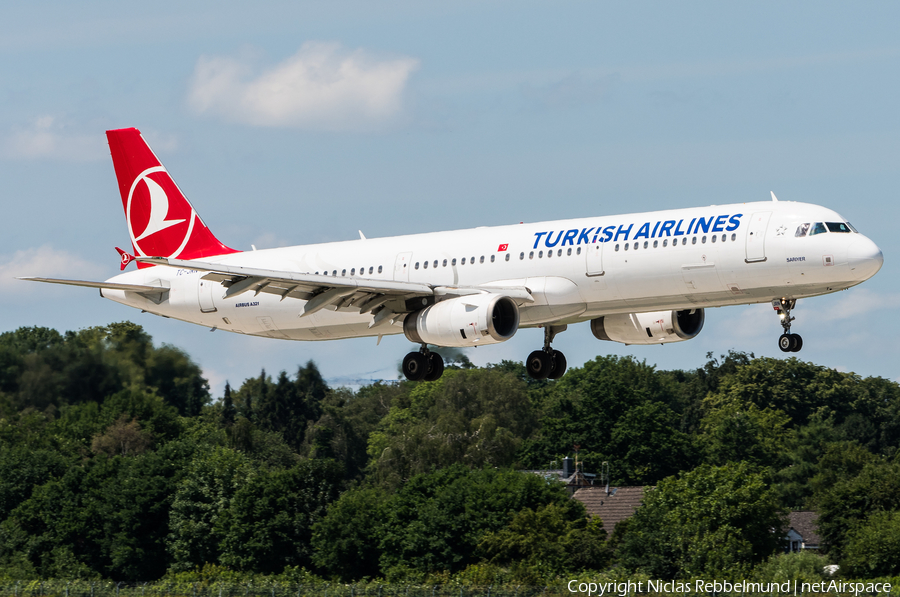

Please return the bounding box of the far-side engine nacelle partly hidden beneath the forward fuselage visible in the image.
[591,309,706,344]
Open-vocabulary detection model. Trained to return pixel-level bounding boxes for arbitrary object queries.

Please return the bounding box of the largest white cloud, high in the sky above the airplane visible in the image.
[188,42,419,130]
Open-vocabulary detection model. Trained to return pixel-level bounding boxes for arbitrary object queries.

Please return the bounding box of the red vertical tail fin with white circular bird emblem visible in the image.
[106,128,238,268]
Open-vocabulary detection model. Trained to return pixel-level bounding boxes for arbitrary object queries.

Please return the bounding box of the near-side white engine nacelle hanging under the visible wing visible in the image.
[403,294,519,347]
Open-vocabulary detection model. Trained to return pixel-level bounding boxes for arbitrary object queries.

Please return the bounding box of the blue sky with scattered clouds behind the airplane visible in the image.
[0,1,900,393]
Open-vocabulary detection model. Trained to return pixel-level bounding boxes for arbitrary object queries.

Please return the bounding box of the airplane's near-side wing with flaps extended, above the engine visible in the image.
[137,257,534,327]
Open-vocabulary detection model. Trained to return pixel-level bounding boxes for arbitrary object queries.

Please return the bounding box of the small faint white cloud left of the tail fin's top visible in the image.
[0,116,107,162]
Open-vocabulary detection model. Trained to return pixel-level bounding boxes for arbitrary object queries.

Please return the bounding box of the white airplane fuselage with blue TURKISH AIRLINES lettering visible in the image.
[103,201,882,340]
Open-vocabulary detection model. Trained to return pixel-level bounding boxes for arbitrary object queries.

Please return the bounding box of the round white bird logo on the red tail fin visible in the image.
[125,166,197,257]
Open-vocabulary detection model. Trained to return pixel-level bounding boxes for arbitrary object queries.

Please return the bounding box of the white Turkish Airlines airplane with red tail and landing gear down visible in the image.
[22,128,884,381]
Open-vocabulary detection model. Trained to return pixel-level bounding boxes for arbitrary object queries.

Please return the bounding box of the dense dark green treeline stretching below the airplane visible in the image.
[0,323,900,585]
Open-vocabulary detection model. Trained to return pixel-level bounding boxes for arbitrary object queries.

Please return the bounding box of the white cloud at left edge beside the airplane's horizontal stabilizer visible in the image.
[0,245,103,292]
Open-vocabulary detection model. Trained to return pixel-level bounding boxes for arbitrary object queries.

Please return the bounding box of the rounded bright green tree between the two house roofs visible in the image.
[619,463,784,578]
